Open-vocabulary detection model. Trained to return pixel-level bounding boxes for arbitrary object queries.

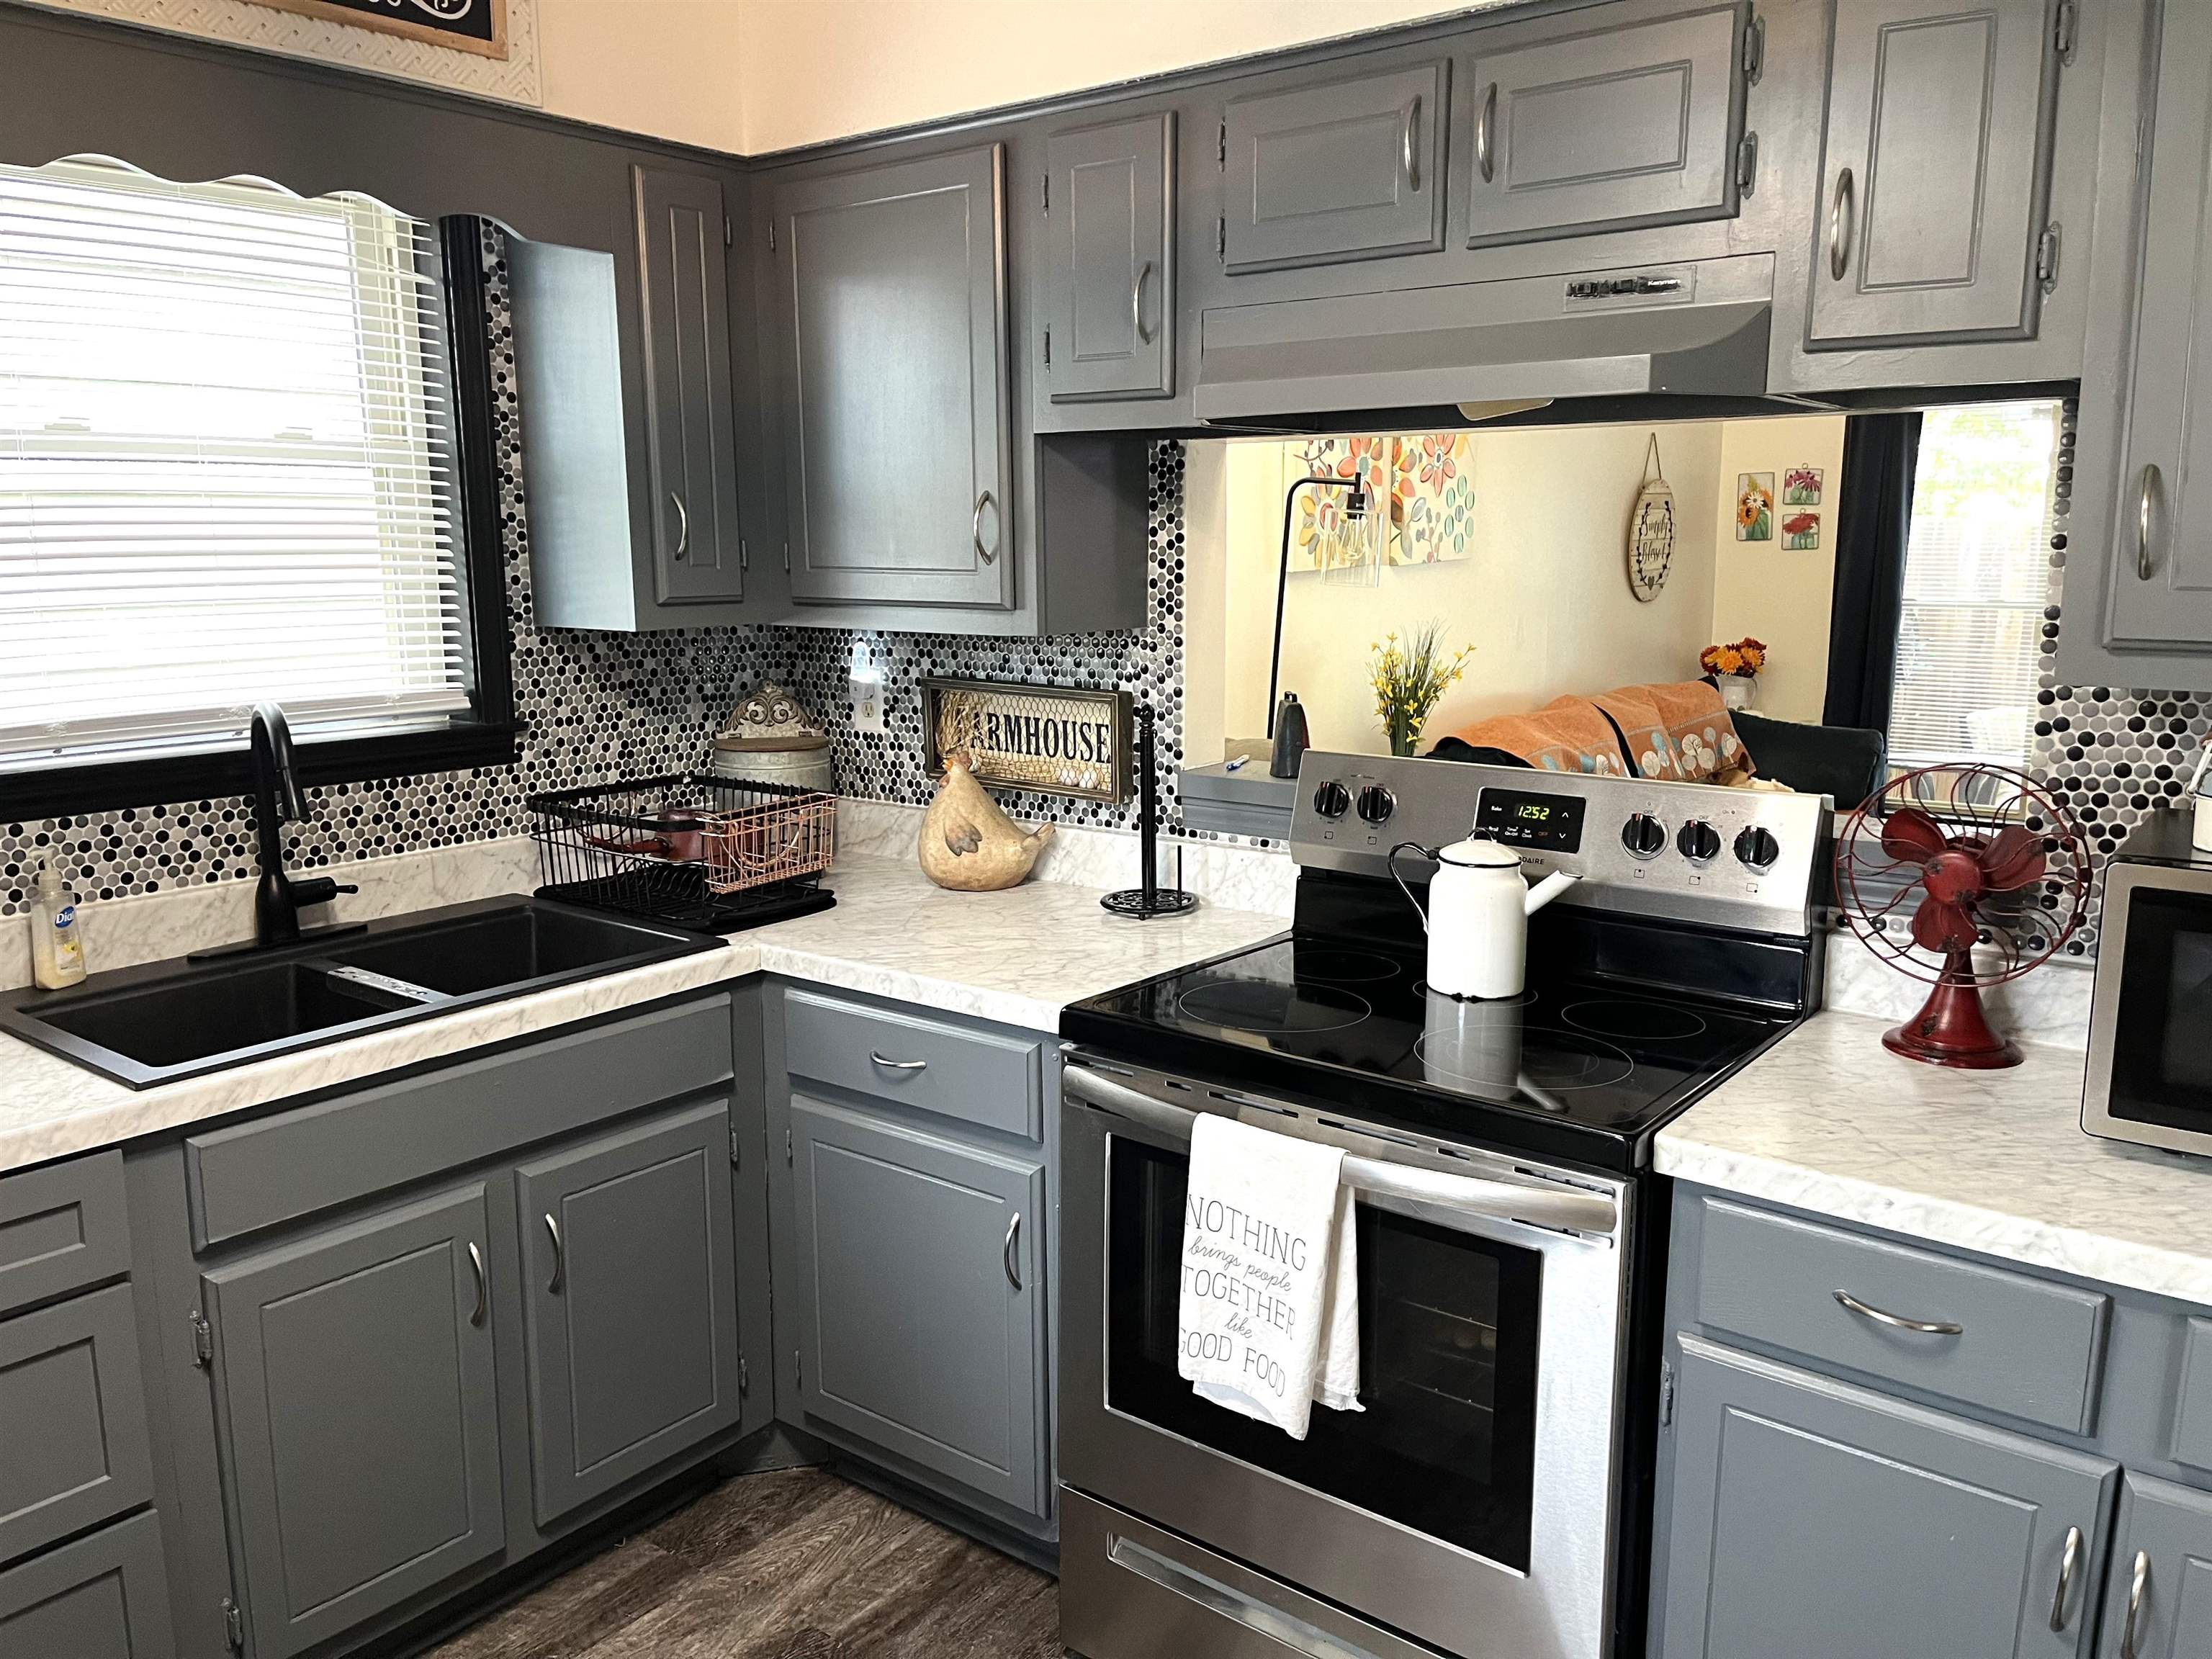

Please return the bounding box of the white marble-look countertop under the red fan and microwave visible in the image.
[1655,1013,2212,1305]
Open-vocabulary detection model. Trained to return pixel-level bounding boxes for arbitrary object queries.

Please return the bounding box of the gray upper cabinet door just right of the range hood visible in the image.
[1809,0,2057,347]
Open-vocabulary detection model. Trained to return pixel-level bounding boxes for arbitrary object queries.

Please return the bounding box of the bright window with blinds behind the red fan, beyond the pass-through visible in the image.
[1889,403,2059,770]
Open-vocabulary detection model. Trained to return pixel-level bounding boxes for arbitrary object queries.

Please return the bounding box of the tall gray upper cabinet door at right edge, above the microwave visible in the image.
[2106,0,2212,646]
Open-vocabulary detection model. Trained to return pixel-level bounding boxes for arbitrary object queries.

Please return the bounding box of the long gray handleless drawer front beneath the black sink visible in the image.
[184,995,730,1250]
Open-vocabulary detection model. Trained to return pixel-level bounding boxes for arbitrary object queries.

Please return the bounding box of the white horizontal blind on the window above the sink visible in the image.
[0,157,469,768]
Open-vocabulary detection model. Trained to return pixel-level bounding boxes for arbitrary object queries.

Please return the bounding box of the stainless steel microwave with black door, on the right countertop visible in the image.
[2082,865,2212,1153]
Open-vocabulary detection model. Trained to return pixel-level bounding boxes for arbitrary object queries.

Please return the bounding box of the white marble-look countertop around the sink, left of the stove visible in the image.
[0,856,1285,1170]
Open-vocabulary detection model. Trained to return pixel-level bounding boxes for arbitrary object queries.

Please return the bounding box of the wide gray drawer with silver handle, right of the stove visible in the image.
[1696,1199,2110,1434]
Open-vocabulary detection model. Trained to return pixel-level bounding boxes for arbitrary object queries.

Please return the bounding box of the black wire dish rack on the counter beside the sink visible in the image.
[526,772,836,933]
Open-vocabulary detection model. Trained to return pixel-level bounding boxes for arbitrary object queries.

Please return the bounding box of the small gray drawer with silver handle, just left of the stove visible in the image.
[783,991,1044,1139]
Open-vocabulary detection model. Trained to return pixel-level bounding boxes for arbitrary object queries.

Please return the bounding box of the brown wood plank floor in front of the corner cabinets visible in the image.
[431,1469,1062,1659]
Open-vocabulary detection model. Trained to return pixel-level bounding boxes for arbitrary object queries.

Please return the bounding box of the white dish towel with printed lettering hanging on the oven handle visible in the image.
[1177,1112,1364,1440]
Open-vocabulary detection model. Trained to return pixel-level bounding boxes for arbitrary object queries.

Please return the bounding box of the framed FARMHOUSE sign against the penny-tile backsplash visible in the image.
[922,679,1130,801]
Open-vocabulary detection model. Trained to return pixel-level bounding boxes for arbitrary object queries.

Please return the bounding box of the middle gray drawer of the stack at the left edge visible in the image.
[0,1285,153,1562]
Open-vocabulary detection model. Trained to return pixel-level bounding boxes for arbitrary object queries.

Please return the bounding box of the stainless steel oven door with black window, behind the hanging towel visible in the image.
[1059,1062,1630,1659]
